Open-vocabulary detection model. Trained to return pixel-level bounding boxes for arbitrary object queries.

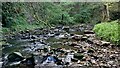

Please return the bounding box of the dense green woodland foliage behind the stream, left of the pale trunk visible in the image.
[2,2,119,34]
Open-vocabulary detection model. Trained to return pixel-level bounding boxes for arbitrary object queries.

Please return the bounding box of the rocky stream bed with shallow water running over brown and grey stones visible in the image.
[2,24,120,68]
